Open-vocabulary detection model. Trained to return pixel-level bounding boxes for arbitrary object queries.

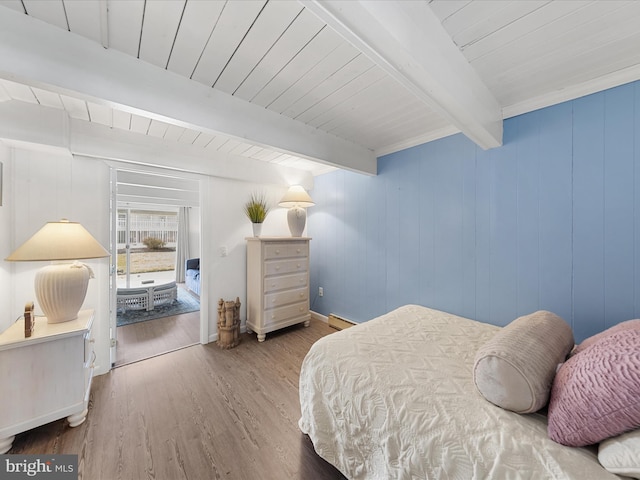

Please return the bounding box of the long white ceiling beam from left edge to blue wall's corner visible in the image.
[0,9,377,175]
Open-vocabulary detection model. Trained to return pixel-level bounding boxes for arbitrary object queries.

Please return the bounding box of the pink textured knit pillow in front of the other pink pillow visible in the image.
[548,326,640,447]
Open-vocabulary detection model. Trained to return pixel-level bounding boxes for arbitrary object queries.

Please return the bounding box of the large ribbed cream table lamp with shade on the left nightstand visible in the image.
[5,219,109,323]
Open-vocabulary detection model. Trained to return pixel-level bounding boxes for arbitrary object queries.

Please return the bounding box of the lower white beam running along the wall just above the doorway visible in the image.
[0,100,313,189]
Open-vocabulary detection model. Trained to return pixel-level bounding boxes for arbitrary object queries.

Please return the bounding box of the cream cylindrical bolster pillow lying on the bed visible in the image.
[473,310,574,413]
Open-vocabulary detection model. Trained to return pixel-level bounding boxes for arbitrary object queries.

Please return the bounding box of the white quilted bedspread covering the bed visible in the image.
[299,305,618,480]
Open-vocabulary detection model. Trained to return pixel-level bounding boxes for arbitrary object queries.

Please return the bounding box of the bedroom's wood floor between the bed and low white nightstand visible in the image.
[9,320,344,480]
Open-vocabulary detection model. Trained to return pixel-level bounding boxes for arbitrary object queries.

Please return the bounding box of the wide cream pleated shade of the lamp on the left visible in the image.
[5,219,109,262]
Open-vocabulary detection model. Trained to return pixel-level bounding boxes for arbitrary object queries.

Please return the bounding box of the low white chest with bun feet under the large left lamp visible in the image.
[0,310,95,453]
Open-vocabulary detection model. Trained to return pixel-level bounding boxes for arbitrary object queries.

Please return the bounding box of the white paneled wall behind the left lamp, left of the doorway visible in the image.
[2,147,110,373]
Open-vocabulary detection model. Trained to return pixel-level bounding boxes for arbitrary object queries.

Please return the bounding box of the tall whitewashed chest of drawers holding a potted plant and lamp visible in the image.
[247,237,311,342]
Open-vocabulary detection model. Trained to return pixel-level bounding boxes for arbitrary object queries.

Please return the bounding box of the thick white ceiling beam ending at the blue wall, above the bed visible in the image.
[300,0,502,149]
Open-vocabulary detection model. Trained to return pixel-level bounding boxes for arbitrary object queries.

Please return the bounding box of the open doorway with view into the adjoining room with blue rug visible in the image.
[110,170,202,367]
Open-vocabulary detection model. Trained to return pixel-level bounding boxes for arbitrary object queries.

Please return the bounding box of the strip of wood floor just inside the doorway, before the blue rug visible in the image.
[115,312,200,367]
